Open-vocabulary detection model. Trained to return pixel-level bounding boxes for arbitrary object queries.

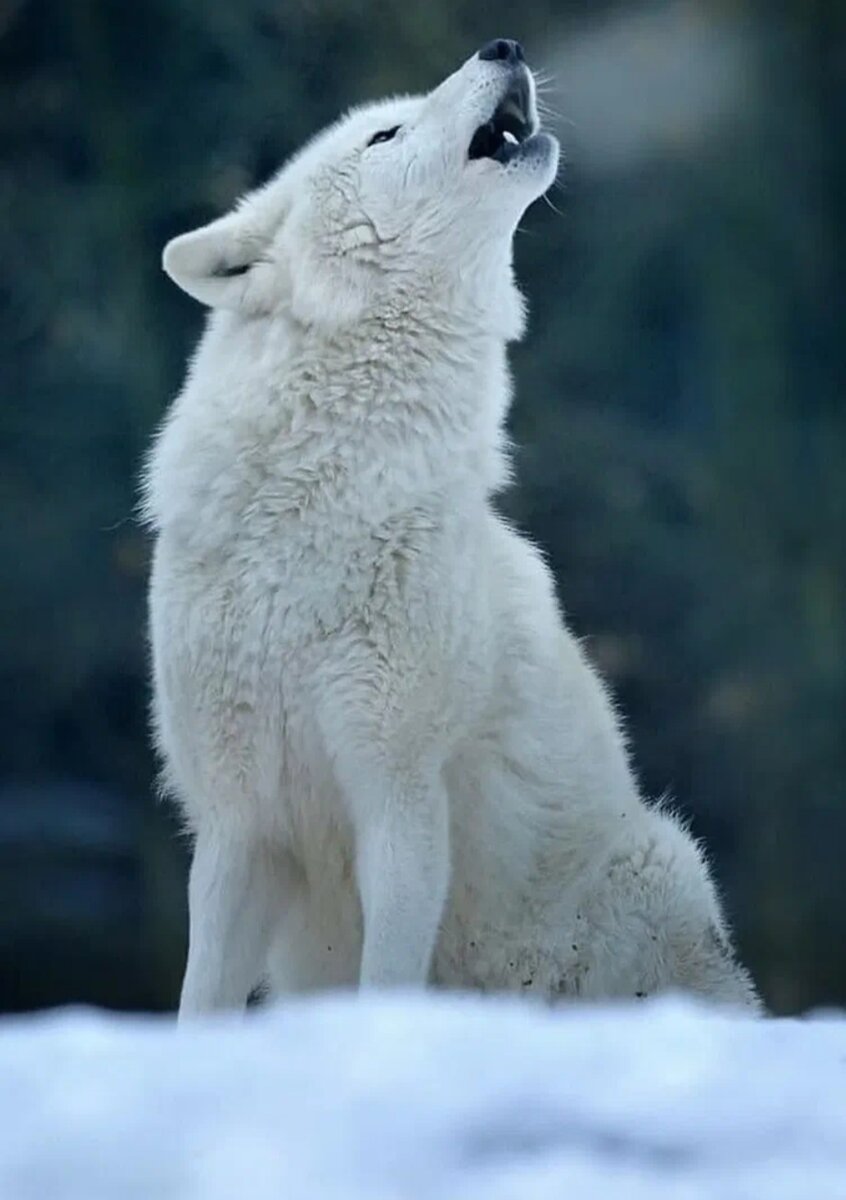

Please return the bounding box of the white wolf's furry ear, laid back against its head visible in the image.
[162,211,270,308]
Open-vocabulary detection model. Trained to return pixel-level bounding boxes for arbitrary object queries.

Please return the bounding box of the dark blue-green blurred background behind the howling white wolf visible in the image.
[0,0,846,1013]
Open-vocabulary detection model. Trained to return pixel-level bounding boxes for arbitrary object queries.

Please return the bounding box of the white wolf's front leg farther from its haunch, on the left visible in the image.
[179,829,294,1021]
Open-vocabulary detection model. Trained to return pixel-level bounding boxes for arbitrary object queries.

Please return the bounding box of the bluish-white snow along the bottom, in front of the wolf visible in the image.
[0,995,846,1200]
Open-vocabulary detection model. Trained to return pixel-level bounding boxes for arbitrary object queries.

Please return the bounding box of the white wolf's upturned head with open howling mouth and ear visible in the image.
[163,40,558,335]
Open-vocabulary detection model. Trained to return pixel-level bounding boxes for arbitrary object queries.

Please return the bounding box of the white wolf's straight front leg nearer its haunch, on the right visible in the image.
[355,779,450,989]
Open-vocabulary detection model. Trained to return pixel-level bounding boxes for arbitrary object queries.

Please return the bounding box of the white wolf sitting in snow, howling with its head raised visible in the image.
[146,40,757,1014]
